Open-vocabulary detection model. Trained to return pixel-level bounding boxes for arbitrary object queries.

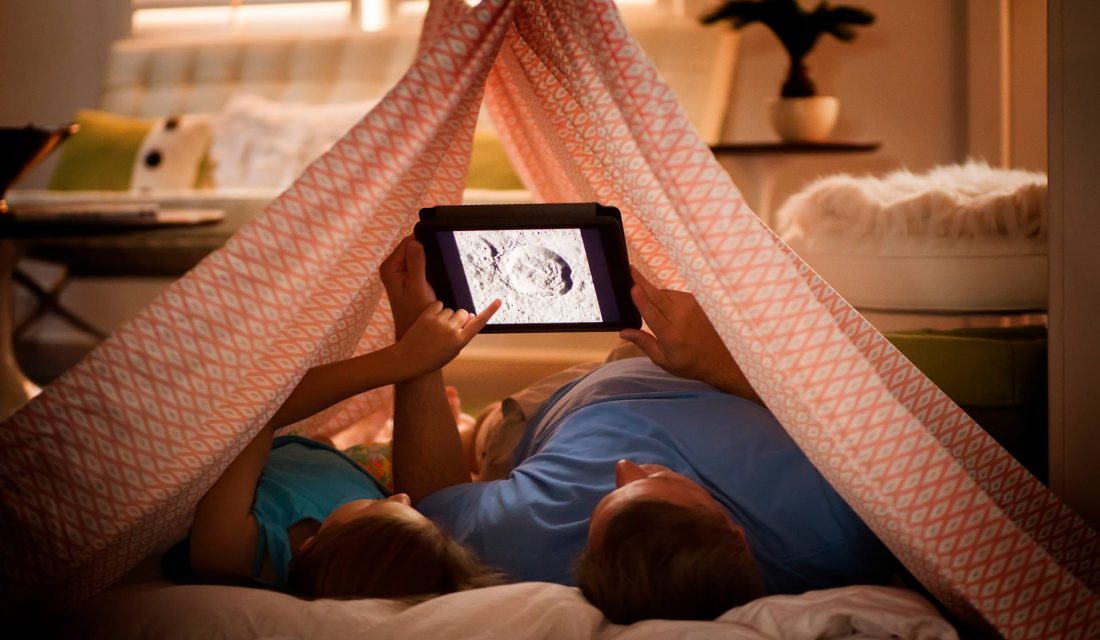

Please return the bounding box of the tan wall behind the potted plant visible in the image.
[726,0,967,217]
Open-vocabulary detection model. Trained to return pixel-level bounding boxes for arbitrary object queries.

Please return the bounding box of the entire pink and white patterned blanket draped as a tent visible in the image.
[0,0,1100,638]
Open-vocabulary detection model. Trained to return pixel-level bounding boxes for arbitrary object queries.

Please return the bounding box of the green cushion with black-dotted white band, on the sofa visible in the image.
[47,109,211,191]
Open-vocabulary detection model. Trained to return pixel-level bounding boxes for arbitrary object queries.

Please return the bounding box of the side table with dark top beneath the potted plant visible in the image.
[711,142,881,227]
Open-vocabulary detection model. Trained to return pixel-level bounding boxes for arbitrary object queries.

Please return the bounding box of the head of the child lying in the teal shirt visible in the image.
[289,494,498,598]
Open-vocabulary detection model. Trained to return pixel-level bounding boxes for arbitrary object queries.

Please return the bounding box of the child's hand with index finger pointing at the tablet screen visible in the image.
[395,300,501,375]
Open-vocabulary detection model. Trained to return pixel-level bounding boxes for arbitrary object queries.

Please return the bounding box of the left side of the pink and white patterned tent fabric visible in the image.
[0,2,514,610]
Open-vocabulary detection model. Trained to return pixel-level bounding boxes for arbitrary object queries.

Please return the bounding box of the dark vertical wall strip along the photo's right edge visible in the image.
[1049,0,1100,529]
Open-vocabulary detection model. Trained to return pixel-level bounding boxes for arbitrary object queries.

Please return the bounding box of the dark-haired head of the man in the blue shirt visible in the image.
[576,460,767,625]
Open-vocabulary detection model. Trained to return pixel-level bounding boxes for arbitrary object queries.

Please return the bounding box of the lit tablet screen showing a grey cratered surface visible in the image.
[436,228,622,325]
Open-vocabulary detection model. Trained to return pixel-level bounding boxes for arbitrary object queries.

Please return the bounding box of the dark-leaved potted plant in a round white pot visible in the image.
[702,0,875,142]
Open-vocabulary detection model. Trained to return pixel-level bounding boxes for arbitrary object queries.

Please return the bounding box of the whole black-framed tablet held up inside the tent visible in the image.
[414,203,641,333]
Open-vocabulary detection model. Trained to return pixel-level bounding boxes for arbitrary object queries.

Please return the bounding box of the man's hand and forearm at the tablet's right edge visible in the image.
[619,267,760,402]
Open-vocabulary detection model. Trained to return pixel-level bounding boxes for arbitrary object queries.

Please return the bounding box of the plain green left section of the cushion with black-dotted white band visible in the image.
[48,109,154,191]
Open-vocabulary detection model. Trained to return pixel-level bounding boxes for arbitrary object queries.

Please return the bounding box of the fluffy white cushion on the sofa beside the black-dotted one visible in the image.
[210,95,376,189]
